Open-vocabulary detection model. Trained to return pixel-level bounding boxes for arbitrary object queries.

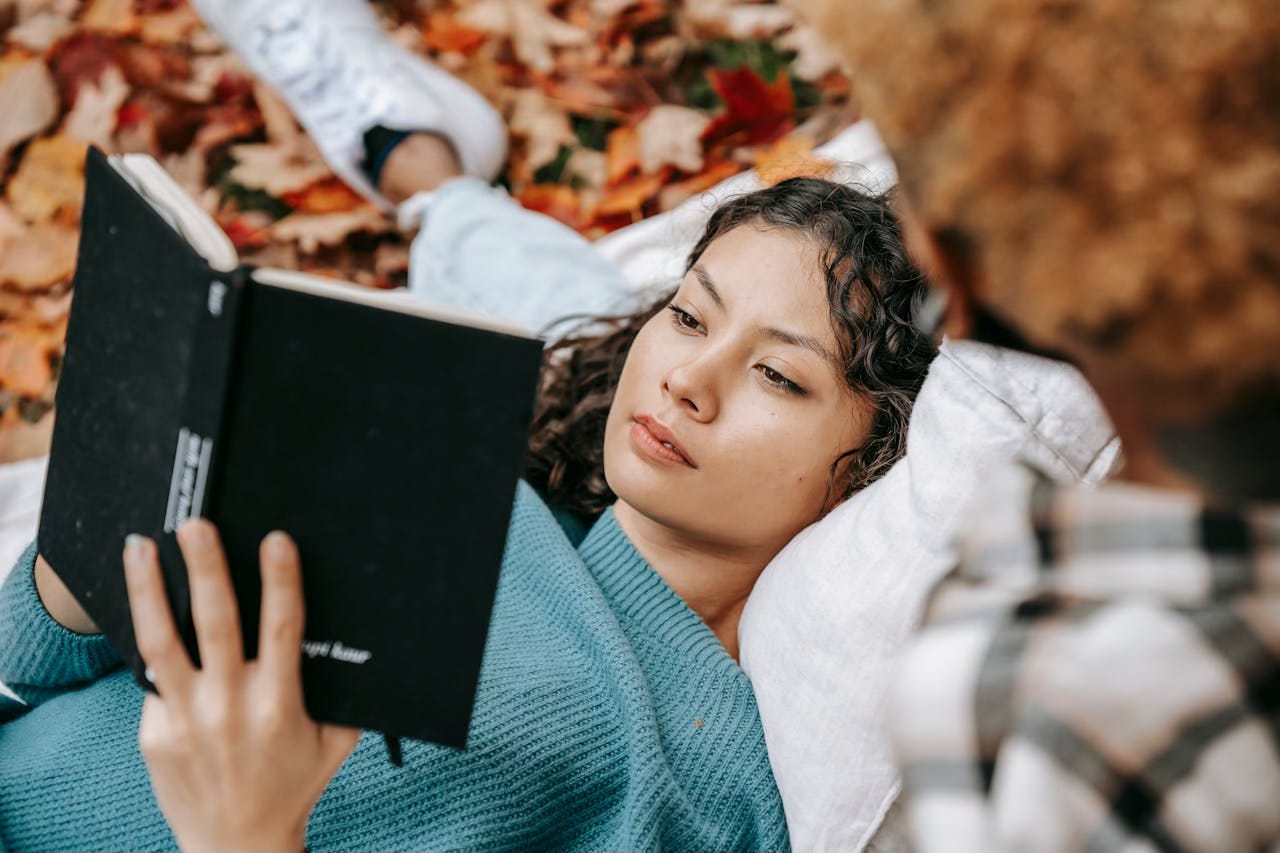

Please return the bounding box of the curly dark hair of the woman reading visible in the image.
[525,178,934,517]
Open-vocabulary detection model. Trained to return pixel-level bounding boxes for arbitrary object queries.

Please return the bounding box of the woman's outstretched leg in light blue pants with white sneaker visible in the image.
[193,0,634,332]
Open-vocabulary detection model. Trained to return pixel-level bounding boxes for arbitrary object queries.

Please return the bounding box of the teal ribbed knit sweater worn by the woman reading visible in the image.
[0,484,787,850]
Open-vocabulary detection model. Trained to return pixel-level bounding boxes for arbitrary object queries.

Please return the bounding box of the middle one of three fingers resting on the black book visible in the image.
[178,519,244,678]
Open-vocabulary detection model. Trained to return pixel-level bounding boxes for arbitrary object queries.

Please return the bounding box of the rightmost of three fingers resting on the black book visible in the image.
[257,530,306,695]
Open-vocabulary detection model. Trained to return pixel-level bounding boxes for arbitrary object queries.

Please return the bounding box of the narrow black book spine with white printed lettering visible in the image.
[164,268,250,533]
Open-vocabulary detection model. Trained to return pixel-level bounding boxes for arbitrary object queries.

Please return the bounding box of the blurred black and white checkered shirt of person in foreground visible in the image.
[892,469,1280,853]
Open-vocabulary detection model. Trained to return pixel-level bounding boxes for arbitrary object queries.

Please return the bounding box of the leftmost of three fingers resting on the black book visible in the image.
[124,535,196,698]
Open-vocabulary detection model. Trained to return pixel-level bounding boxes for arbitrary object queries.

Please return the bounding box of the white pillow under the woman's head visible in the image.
[739,341,1119,852]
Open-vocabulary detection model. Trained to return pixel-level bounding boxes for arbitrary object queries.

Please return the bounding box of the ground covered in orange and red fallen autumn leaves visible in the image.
[0,0,852,462]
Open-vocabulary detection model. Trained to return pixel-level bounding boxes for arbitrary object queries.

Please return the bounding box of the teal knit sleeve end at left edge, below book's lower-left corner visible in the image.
[0,543,120,716]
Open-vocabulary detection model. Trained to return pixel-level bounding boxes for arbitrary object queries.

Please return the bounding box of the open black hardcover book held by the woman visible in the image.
[38,150,541,747]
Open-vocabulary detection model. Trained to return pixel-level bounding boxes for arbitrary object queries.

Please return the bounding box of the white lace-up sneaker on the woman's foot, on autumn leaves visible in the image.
[191,0,507,209]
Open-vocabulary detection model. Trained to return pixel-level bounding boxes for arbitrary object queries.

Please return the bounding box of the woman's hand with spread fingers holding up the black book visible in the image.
[124,520,360,850]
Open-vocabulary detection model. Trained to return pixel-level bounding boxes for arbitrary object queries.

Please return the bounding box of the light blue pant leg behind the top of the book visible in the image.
[407,178,636,333]
